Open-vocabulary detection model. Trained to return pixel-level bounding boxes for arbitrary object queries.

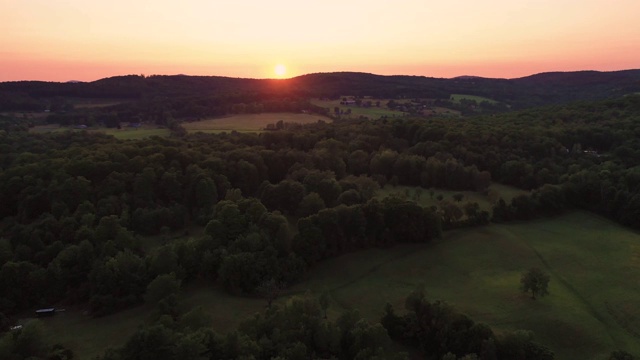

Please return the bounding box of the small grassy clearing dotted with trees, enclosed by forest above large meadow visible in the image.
[376,183,528,212]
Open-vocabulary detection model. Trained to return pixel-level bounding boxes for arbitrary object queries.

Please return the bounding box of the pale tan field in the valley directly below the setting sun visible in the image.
[182,113,333,133]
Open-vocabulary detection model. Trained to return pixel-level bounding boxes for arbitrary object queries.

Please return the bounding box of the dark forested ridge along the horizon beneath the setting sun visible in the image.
[0,70,640,111]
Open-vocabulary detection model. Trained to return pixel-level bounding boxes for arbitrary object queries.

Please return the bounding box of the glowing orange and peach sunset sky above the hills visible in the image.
[0,0,640,81]
